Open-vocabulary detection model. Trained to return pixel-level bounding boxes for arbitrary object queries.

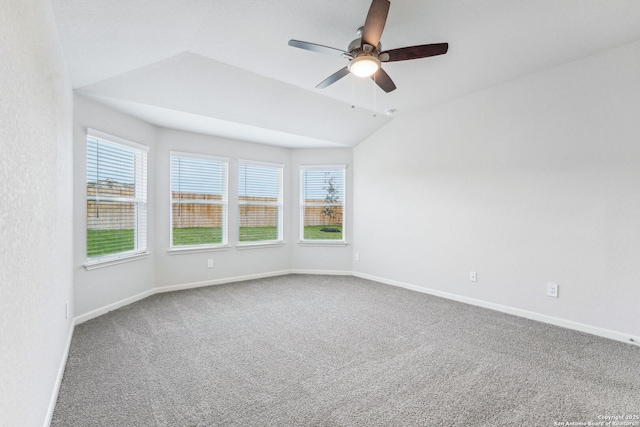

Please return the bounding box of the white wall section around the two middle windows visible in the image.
[155,129,292,287]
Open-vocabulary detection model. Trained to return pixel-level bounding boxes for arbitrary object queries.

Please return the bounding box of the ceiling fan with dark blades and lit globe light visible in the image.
[289,0,449,93]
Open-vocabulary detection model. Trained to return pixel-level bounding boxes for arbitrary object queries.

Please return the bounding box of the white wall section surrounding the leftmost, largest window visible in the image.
[73,95,156,315]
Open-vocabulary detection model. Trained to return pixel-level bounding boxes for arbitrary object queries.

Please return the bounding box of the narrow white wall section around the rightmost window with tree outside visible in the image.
[289,148,353,273]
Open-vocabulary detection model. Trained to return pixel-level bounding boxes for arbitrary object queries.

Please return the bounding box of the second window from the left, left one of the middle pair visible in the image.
[171,152,228,249]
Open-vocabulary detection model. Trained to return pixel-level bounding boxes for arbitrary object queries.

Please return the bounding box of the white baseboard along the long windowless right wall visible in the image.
[353,271,640,345]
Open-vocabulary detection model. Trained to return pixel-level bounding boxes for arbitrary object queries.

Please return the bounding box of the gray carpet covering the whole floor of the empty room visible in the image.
[52,275,640,427]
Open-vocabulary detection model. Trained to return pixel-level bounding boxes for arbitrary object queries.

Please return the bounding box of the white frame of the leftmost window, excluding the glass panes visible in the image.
[84,128,150,270]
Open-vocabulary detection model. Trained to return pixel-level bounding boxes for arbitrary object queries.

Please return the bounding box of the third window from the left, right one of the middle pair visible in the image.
[238,160,284,243]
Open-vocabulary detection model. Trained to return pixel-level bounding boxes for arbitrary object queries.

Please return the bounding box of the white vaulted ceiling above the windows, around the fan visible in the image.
[51,0,640,147]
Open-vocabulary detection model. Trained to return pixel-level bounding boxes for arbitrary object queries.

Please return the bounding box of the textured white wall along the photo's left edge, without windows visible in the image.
[0,0,73,426]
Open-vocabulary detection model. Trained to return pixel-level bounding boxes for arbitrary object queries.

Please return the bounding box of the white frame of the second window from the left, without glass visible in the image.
[167,151,229,254]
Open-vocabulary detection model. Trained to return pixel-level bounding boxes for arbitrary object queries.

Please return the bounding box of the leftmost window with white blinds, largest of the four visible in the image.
[87,129,148,263]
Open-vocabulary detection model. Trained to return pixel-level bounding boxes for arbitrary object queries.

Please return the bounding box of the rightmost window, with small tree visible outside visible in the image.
[300,166,345,243]
